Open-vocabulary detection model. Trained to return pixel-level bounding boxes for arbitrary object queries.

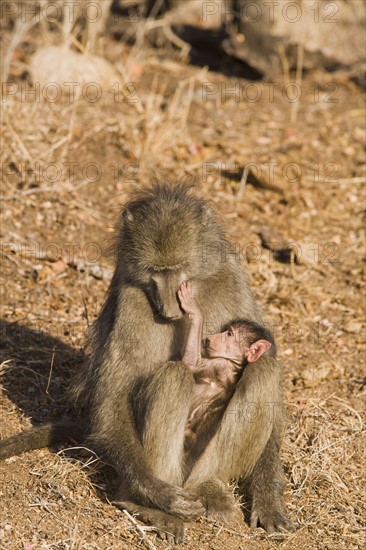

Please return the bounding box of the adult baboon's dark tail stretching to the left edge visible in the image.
[0,420,86,460]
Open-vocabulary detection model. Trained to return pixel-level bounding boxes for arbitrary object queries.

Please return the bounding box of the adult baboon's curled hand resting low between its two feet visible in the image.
[161,486,205,520]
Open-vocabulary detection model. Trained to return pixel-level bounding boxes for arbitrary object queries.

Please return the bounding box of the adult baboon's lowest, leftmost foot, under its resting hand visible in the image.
[113,500,185,544]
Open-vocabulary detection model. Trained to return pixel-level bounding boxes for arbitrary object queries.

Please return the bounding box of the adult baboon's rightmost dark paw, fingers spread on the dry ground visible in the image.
[250,499,296,533]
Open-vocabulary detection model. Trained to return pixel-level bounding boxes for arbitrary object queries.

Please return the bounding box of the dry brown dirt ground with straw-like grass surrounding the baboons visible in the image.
[0,5,365,550]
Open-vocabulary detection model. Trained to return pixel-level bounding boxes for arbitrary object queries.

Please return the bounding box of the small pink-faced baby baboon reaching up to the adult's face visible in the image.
[178,282,275,475]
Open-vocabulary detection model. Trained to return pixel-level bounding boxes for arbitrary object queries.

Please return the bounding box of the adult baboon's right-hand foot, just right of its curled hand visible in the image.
[196,481,244,528]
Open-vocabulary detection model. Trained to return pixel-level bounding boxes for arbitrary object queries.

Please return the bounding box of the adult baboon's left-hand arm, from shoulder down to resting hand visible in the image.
[91,287,204,519]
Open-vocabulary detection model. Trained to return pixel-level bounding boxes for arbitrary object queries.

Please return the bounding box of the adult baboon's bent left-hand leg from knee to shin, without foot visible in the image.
[137,361,194,485]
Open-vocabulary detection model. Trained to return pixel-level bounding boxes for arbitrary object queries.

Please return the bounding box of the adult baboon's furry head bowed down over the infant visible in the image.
[119,187,222,320]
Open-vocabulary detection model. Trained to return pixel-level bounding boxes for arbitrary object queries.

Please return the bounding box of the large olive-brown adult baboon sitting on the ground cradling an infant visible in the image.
[0,183,291,542]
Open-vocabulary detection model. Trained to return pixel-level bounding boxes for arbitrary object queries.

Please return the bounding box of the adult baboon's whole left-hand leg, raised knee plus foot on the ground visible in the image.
[114,361,194,543]
